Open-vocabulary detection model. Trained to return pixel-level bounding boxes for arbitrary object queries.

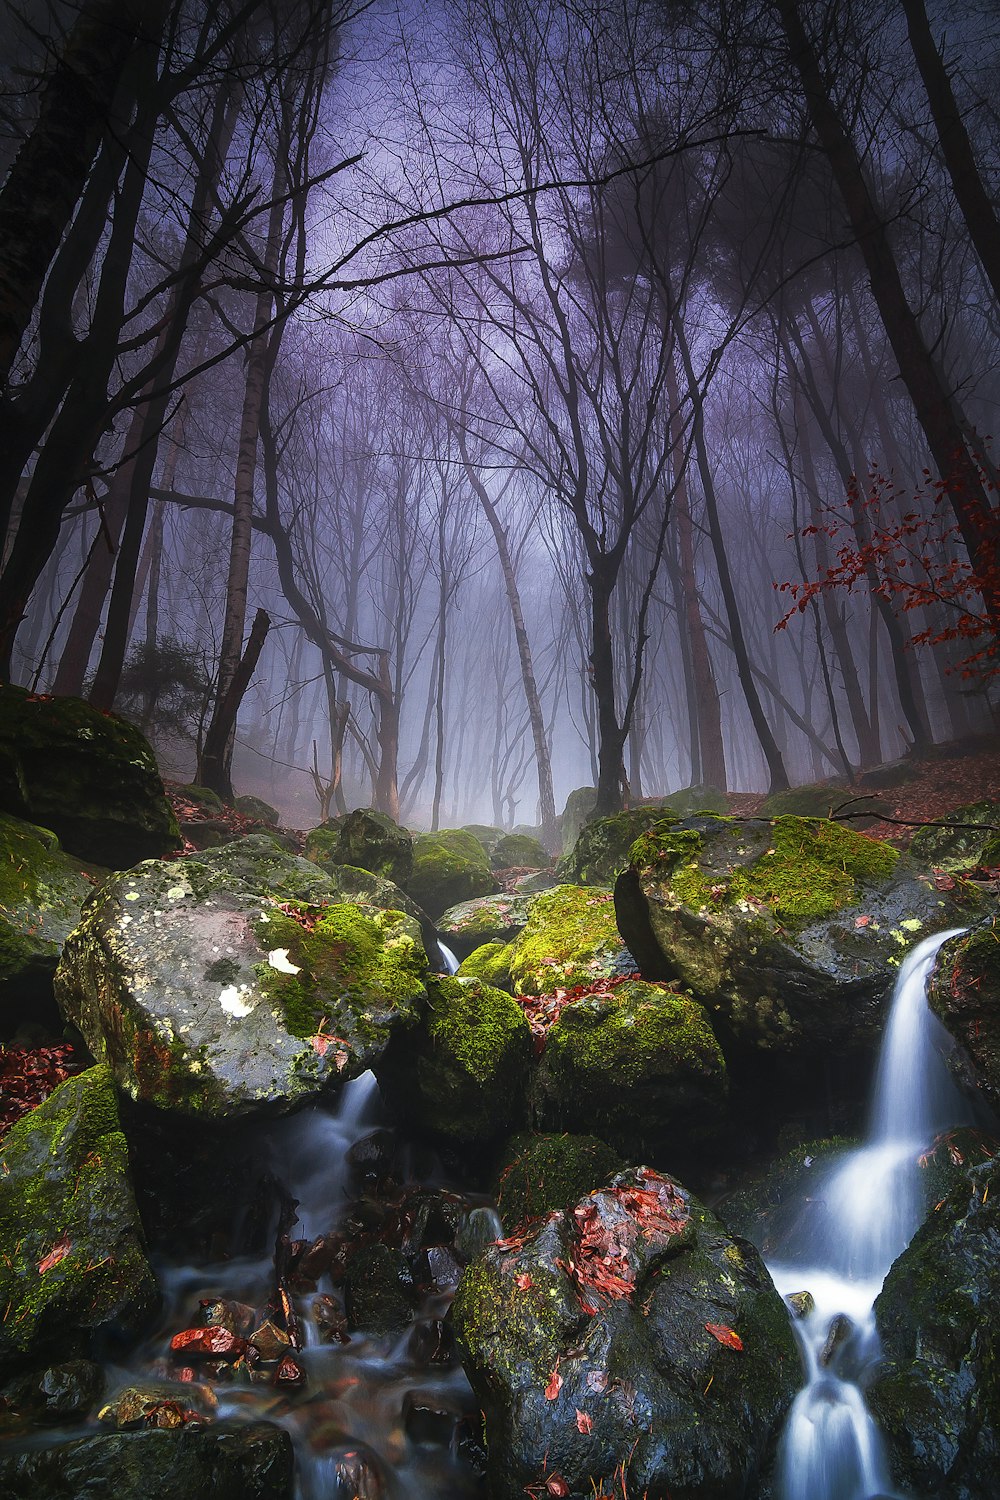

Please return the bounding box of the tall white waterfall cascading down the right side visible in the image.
[769,930,969,1500]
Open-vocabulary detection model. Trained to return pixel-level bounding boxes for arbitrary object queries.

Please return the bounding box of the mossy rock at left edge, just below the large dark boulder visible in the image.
[0,815,106,1010]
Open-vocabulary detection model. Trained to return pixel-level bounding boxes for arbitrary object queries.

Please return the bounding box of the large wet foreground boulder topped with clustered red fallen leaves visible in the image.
[453,1169,799,1500]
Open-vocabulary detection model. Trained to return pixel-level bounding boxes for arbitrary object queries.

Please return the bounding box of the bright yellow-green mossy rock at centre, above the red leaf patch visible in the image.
[510,885,636,995]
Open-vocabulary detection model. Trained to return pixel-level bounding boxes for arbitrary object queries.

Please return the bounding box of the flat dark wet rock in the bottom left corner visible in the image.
[0,1422,294,1500]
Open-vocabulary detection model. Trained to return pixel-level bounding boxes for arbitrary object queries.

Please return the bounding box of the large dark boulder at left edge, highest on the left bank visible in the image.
[0,687,180,870]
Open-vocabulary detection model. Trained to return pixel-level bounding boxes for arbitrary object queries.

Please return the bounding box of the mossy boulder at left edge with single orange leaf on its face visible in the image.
[0,1067,159,1371]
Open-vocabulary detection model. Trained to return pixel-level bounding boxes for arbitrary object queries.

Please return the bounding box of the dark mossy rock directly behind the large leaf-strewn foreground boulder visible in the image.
[496,1133,625,1235]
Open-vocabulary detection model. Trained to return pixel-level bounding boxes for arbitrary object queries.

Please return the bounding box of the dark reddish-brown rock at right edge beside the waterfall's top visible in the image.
[928,915,1000,1115]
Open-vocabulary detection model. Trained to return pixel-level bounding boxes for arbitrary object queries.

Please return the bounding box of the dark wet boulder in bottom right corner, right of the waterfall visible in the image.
[868,1161,1000,1500]
